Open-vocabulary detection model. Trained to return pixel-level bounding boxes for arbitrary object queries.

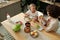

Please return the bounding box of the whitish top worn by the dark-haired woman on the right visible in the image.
[46,18,59,32]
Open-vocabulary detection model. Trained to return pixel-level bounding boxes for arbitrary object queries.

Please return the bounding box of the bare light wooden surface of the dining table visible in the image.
[1,13,60,40]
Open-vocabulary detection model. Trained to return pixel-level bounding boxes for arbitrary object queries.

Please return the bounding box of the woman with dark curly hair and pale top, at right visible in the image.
[43,5,59,32]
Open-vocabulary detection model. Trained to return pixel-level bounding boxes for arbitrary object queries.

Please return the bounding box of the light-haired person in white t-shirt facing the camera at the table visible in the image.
[25,4,42,21]
